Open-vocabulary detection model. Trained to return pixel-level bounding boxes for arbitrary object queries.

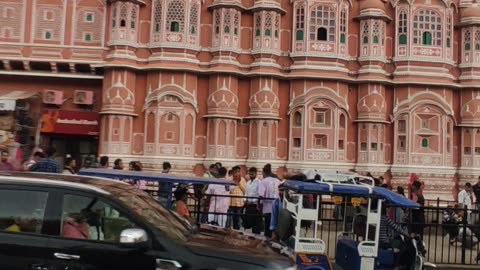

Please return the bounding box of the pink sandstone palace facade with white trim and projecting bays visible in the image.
[0,0,480,198]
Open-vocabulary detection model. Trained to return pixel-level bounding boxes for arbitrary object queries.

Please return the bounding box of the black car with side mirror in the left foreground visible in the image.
[0,172,295,270]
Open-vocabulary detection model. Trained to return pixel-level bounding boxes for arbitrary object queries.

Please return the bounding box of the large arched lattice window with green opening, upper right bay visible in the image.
[413,9,443,46]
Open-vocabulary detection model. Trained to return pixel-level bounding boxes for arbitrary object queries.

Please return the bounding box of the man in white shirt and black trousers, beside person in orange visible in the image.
[243,167,262,234]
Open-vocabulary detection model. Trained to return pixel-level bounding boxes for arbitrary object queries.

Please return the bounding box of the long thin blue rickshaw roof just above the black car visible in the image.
[78,168,235,185]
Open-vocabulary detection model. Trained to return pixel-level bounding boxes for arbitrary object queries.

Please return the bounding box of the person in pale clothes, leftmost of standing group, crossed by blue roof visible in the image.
[205,167,230,227]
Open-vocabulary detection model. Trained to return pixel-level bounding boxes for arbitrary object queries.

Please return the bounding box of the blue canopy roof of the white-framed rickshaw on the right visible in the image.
[283,180,420,208]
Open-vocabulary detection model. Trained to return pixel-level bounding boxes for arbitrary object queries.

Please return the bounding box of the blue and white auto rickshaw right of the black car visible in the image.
[279,173,435,270]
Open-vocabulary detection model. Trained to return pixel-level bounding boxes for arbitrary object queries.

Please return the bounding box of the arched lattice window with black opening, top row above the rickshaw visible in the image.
[310,6,335,42]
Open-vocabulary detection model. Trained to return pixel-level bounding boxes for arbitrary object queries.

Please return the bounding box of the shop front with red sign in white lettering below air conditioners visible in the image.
[40,109,100,167]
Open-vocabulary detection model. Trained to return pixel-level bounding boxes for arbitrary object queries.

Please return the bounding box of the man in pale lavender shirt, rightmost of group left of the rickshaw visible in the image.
[258,164,280,238]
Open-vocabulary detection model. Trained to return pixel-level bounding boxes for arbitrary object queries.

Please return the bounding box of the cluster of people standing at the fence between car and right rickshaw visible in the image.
[175,163,282,237]
